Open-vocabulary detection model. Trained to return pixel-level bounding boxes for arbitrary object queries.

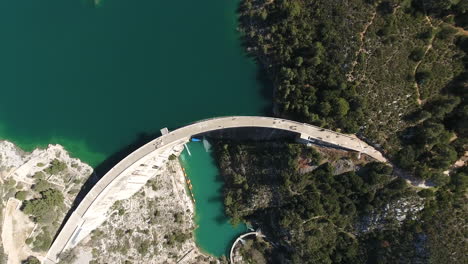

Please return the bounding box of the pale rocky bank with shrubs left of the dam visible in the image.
[0,141,93,264]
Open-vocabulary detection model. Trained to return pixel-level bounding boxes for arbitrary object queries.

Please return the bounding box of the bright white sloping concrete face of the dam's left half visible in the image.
[44,139,188,263]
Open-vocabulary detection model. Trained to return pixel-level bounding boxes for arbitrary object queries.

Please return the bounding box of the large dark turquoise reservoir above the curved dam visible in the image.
[0,0,269,166]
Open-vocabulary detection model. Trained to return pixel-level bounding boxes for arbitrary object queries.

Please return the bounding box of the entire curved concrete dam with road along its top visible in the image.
[43,116,386,263]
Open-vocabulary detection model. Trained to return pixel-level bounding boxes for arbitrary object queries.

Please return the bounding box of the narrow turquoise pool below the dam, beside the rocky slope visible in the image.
[180,142,247,257]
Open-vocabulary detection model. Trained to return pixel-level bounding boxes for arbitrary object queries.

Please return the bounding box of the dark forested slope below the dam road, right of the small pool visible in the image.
[215,141,468,263]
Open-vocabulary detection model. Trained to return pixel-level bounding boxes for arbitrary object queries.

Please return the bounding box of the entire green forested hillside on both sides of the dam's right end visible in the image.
[216,0,468,263]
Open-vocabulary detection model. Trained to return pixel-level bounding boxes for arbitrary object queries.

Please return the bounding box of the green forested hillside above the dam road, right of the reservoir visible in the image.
[239,0,468,183]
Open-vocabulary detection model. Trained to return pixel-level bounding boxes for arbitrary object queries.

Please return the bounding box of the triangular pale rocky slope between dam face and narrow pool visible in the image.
[70,159,217,263]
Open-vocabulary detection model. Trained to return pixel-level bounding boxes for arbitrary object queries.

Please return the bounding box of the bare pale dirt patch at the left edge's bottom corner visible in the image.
[2,198,34,264]
